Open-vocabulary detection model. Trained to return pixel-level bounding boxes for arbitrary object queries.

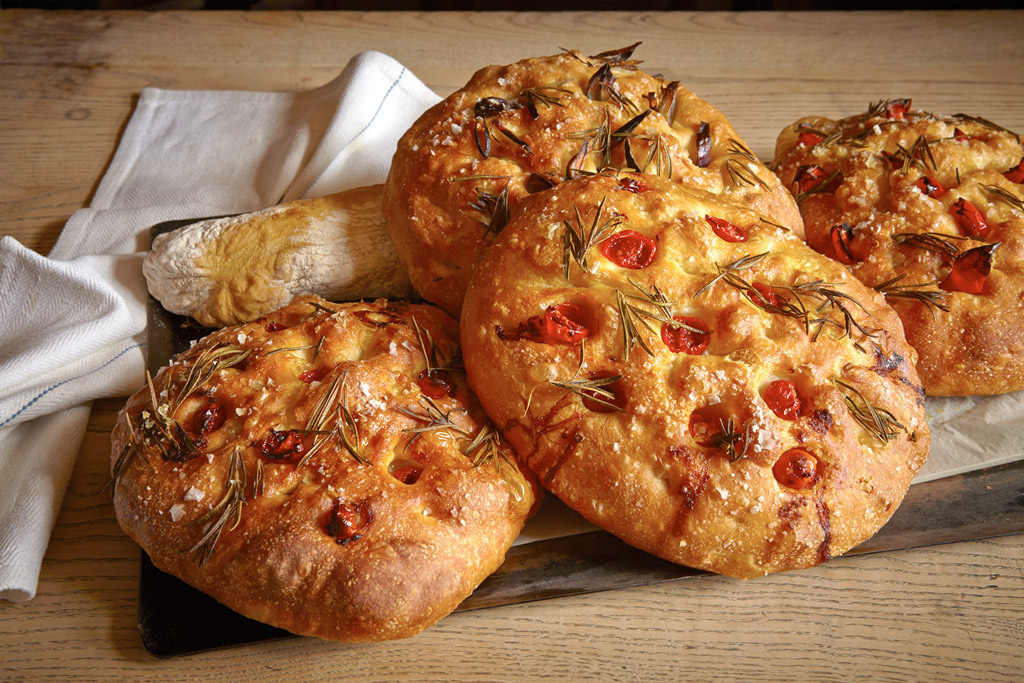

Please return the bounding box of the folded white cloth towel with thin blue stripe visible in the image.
[0,52,439,600]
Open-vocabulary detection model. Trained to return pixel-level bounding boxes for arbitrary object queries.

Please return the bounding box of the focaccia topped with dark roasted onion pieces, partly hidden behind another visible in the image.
[384,45,803,315]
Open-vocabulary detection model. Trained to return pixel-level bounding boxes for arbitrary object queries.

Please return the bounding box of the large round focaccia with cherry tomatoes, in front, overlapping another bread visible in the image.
[462,175,929,578]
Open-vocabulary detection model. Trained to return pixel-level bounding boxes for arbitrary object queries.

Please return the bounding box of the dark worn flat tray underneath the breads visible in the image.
[138,220,1024,657]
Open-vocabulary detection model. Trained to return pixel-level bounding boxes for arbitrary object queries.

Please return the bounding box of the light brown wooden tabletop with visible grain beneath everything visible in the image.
[0,10,1024,681]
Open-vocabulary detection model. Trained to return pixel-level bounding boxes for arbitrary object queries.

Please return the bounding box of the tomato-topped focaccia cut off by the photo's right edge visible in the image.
[775,100,1024,395]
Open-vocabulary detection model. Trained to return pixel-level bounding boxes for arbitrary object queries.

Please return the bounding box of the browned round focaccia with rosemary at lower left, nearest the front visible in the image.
[113,297,539,641]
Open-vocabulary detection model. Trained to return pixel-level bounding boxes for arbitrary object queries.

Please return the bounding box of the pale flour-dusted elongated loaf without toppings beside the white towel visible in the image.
[142,185,410,328]
